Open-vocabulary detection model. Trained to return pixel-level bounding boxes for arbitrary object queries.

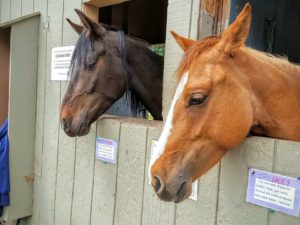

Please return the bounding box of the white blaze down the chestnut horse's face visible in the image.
[148,72,188,183]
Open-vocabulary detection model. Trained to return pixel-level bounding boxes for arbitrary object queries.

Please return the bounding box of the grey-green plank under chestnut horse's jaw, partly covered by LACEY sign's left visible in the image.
[217,137,275,225]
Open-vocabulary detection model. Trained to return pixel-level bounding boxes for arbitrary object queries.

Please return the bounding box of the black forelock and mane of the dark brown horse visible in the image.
[68,24,148,117]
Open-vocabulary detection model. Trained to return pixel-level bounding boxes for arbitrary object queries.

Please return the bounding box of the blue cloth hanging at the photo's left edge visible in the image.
[0,120,10,206]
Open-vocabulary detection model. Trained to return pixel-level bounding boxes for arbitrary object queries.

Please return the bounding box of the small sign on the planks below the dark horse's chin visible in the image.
[96,137,118,164]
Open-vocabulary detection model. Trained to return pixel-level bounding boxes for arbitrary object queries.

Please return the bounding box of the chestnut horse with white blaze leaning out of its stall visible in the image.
[149,4,300,203]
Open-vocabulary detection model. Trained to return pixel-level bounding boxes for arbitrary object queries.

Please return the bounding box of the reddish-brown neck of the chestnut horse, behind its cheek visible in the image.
[240,49,300,141]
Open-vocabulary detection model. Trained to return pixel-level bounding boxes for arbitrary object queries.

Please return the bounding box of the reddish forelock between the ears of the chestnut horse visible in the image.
[175,36,220,81]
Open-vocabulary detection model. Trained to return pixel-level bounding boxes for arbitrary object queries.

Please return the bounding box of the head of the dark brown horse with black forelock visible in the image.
[60,10,127,136]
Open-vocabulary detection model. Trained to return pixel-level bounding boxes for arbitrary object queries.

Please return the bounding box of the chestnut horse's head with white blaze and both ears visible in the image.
[149,4,253,202]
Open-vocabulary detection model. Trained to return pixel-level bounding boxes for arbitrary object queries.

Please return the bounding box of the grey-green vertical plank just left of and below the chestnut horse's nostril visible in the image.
[142,127,175,225]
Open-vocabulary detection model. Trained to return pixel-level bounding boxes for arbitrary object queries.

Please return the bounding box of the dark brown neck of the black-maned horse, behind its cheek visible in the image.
[126,37,163,120]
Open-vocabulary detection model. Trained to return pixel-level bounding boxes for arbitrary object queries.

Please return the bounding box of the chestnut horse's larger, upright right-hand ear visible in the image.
[219,3,251,54]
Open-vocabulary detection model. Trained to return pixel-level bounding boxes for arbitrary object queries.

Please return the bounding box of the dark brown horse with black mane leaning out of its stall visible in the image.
[60,9,163,137]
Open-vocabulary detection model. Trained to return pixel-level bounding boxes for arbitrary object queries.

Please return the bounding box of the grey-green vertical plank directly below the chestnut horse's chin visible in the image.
[176,164,220,225]
